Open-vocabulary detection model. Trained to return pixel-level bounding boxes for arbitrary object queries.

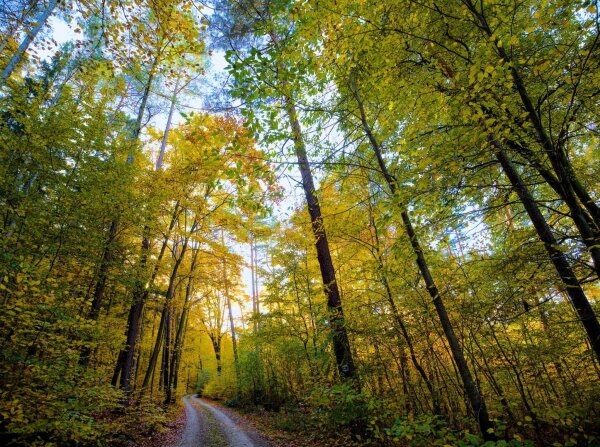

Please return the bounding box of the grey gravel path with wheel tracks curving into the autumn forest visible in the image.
[178,395,269,447]
